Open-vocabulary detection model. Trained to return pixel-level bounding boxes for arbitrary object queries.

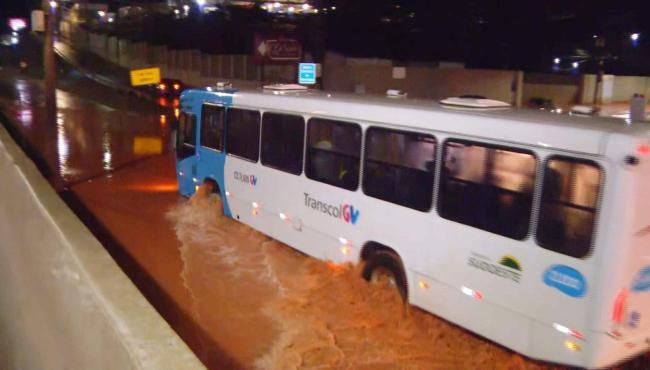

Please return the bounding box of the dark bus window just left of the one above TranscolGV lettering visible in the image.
[262,112,305,175]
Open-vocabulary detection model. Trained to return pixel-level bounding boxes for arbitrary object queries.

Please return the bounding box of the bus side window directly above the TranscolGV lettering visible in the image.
[305,118,361,190]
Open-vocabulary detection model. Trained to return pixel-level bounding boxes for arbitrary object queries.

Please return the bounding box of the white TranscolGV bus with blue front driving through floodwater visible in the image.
[177,88,650,368]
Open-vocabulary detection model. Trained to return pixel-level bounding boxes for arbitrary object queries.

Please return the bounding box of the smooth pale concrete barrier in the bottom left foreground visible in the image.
[0,126,204,369]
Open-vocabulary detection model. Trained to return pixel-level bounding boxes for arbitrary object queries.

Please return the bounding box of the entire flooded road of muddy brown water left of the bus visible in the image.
[0,62,644,369]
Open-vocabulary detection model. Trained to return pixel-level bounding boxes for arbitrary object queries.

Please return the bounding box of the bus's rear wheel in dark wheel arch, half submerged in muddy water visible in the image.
[361,251,408,303]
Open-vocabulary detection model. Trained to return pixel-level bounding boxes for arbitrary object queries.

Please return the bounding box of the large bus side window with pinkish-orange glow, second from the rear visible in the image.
[438,140,537,240]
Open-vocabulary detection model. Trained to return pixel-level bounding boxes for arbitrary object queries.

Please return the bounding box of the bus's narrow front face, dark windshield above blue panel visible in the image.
[176,112,197,196]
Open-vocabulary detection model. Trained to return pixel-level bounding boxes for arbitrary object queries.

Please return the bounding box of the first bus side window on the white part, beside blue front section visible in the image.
[226,108,260,162]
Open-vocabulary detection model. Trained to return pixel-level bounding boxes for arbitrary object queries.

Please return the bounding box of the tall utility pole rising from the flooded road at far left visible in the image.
[43,0,58,117]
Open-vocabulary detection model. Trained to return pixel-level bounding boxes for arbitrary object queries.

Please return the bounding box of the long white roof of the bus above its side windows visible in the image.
[186,89,650,155]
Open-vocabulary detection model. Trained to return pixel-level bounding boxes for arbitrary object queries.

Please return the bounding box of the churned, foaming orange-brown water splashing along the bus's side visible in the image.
[168,190,553,369]
